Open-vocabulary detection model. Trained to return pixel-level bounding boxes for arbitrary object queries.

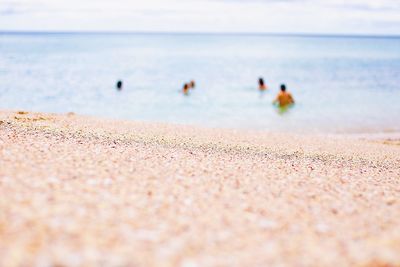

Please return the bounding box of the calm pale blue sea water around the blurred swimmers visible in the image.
[0,33,400,133]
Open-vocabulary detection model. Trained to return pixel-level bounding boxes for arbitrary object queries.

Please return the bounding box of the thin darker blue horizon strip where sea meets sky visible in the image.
[0,30,400,39]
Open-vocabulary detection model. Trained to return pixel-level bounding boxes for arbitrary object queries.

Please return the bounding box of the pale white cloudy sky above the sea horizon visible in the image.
[0,0,400,35]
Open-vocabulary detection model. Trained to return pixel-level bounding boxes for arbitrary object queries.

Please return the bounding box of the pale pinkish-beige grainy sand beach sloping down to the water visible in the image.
[0,111,400,267]
